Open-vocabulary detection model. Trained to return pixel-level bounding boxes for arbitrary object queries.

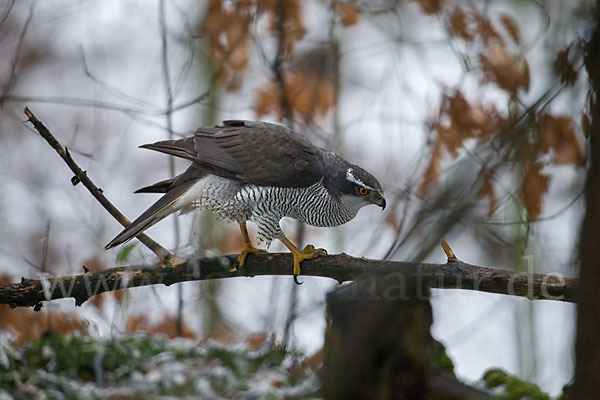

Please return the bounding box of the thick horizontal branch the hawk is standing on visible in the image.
[0,253,577,309]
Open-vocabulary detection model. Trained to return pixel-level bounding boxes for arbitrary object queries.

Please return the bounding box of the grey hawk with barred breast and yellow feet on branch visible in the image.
[106,120,385,276]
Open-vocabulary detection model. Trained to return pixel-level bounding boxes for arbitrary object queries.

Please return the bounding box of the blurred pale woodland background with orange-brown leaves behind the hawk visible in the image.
[0,0,596,393]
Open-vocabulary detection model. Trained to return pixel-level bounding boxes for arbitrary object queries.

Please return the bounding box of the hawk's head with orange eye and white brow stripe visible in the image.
[340,165,385,212]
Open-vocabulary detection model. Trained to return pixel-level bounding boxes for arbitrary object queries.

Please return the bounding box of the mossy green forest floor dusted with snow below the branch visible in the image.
[0,333,560,400]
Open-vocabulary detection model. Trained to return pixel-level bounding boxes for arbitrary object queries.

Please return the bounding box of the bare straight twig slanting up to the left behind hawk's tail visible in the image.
[25,107,176,264]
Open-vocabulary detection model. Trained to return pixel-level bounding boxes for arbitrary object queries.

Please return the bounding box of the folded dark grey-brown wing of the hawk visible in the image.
[142,121,324,187]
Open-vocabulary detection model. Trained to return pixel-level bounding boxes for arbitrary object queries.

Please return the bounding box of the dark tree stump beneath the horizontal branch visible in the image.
[322,268,490,400]
